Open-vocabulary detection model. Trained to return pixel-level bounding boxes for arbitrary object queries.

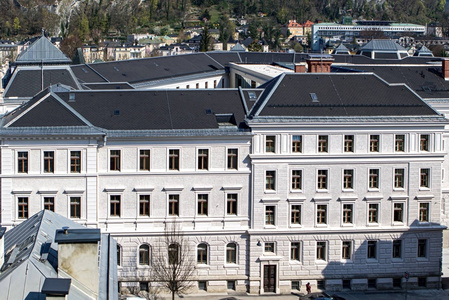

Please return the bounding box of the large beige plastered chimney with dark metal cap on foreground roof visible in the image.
[55,227,101,296]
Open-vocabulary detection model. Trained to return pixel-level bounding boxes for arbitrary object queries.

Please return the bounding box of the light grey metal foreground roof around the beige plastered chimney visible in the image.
[0,210,118,300]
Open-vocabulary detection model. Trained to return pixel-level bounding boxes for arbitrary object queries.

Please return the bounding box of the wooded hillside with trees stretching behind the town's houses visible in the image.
[0,0,449,43]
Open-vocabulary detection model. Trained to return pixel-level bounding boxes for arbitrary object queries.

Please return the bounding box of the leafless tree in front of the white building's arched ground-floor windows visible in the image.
[152,223,195,300]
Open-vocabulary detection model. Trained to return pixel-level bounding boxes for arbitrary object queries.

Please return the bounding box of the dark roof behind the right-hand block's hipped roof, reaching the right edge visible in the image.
[332,65,449,99]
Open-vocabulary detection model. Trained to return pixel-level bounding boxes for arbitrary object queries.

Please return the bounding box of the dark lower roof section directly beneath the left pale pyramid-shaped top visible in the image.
[4,67,77,99]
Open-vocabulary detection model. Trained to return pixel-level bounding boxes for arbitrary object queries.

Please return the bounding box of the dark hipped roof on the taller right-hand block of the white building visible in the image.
[250,73,439,117]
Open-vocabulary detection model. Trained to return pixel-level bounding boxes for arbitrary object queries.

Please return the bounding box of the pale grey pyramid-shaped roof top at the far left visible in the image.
[15,36,72,64]
